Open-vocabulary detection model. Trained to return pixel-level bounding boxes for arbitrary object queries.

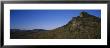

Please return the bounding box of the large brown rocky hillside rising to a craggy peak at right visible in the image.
[11,12,101,39]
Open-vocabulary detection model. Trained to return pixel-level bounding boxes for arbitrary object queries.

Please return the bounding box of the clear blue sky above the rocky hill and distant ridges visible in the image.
[10,10,101,30]
